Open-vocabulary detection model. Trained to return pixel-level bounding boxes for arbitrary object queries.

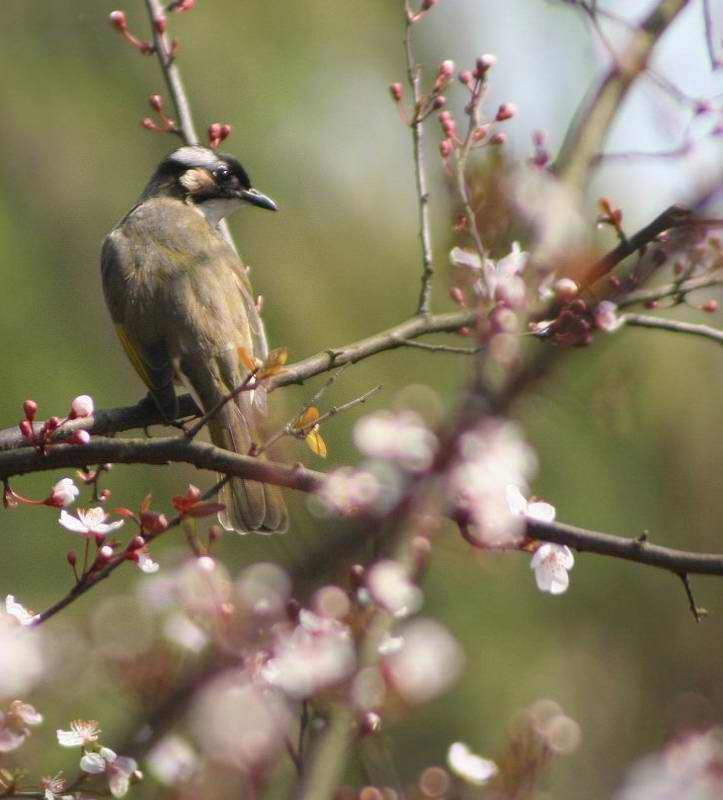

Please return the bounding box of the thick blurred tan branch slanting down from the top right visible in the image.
[555,0,689,189]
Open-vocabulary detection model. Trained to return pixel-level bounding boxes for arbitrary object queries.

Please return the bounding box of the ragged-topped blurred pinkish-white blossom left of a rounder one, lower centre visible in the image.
[261,609,356,700]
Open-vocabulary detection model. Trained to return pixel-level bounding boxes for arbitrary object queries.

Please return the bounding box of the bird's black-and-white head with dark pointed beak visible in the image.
[143,146,276,227]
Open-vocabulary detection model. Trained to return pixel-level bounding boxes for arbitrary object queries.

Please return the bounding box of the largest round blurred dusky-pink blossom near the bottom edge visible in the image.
[191,670,298,771]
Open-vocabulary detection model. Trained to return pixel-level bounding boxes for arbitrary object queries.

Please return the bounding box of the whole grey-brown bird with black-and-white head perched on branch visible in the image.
[101,145,288,534]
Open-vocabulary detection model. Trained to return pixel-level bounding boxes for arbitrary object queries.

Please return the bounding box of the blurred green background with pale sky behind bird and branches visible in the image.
[0,0,723,800]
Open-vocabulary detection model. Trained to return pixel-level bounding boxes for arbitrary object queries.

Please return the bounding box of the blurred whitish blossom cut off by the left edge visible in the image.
[0,614,46,697]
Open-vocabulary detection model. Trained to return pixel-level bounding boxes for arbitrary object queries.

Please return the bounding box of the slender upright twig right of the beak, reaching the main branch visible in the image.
[404,14,434,314]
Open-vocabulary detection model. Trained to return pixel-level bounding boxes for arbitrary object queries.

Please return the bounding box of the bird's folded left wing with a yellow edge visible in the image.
[101,234,178,419]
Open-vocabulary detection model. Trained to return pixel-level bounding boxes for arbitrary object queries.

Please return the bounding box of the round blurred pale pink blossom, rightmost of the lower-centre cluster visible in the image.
[383,619,464,703]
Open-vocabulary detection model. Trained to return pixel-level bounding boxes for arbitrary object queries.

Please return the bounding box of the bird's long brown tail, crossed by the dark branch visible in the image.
[208,402,289,534]
